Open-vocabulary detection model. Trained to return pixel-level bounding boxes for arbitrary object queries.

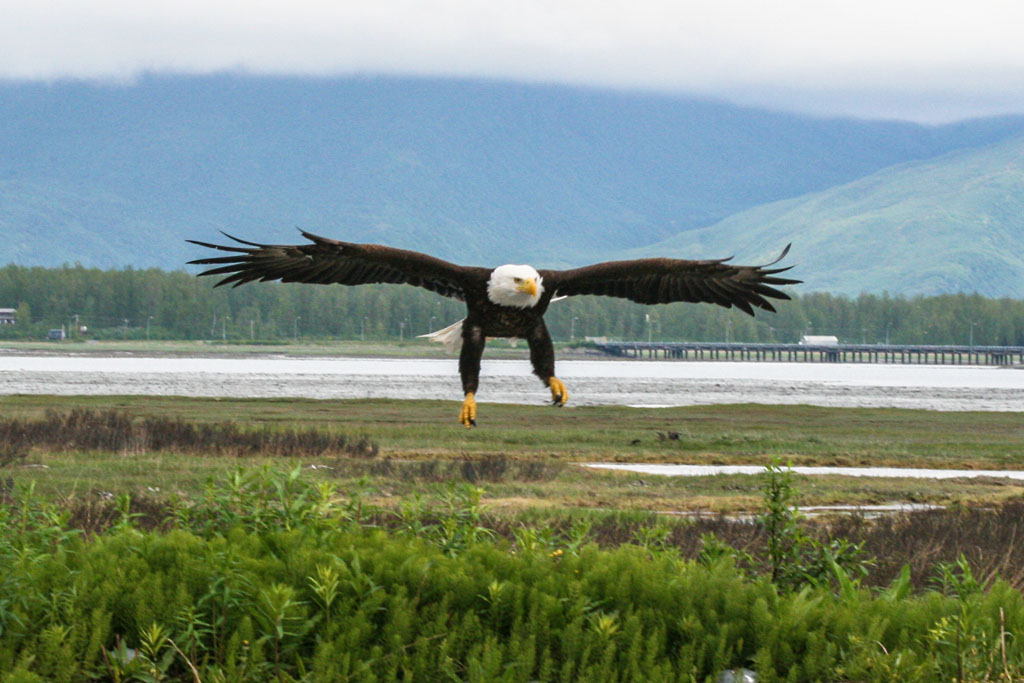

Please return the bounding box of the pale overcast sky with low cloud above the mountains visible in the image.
[0,0,1024,122]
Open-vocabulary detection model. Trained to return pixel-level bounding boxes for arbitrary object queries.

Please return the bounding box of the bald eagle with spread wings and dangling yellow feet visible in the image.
[188,230,800,428]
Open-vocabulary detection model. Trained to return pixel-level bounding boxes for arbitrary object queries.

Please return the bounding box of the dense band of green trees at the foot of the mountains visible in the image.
[0,265,1024,345]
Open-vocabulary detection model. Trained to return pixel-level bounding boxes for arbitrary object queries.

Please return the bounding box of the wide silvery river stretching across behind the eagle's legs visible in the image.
[0,353,1024,411]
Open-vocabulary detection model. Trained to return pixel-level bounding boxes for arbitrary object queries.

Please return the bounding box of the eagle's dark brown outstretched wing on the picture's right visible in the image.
[541,245,800,315]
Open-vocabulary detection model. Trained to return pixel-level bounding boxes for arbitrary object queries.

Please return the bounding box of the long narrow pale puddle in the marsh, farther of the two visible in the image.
[583,463,1024,480]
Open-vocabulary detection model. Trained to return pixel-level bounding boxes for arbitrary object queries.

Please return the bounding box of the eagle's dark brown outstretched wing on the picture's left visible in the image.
[188,230,474,299]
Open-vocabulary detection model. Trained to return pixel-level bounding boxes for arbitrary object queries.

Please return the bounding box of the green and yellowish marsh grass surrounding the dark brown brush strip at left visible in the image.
[6,396,1024,514]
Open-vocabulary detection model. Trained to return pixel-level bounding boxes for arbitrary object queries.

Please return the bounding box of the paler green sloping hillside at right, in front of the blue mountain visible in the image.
[635,136,1024,298]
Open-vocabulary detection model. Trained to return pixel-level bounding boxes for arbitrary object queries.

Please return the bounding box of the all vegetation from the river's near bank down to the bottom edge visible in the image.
[6,396,1024,683]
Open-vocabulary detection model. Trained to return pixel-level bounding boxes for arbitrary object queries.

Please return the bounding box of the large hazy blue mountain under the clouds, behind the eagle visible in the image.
[6,76,1024,278]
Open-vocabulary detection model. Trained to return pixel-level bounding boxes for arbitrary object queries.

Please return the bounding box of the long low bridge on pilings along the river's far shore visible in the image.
[594,342,1024,366]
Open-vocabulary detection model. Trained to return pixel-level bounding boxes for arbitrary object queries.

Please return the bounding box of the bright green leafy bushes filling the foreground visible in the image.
[0,470,1024,683]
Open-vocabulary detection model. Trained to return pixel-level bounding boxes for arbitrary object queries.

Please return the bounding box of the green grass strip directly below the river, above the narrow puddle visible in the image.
[0,396,1024,469]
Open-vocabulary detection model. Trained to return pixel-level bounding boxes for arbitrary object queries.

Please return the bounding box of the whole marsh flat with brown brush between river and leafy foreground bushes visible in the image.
[6,396,1024,587]
